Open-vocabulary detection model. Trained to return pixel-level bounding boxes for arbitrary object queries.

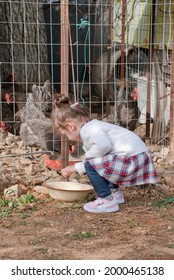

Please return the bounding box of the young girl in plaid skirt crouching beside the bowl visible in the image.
[52,95,157,213]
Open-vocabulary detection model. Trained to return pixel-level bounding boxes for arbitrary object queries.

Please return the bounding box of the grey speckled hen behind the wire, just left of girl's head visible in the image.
[20,81,61,152]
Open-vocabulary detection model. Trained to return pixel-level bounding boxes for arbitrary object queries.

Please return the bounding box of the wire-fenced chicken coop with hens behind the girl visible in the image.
[0,0,174,190]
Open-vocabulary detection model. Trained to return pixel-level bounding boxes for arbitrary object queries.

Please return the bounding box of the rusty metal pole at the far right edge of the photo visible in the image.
[169,22,174,162]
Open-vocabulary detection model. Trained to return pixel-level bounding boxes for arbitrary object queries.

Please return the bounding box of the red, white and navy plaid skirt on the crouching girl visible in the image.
[88,152,157,186]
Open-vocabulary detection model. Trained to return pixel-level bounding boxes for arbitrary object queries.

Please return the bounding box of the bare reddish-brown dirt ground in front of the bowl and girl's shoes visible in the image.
[0,188,174,260]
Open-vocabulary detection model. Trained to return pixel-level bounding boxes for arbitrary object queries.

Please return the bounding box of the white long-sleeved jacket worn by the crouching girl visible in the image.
[75,119,148,174]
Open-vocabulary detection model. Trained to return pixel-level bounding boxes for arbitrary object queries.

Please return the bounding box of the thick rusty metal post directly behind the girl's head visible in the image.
[60,0,69,168]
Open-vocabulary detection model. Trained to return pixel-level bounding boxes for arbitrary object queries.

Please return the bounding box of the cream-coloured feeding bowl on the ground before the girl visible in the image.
[44,181,93,202]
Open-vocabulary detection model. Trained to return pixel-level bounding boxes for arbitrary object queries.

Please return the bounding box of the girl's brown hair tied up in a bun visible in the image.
[52,94,89,127]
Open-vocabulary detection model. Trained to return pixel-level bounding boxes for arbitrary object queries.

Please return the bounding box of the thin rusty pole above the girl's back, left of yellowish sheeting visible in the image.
[120,0,127,94]
